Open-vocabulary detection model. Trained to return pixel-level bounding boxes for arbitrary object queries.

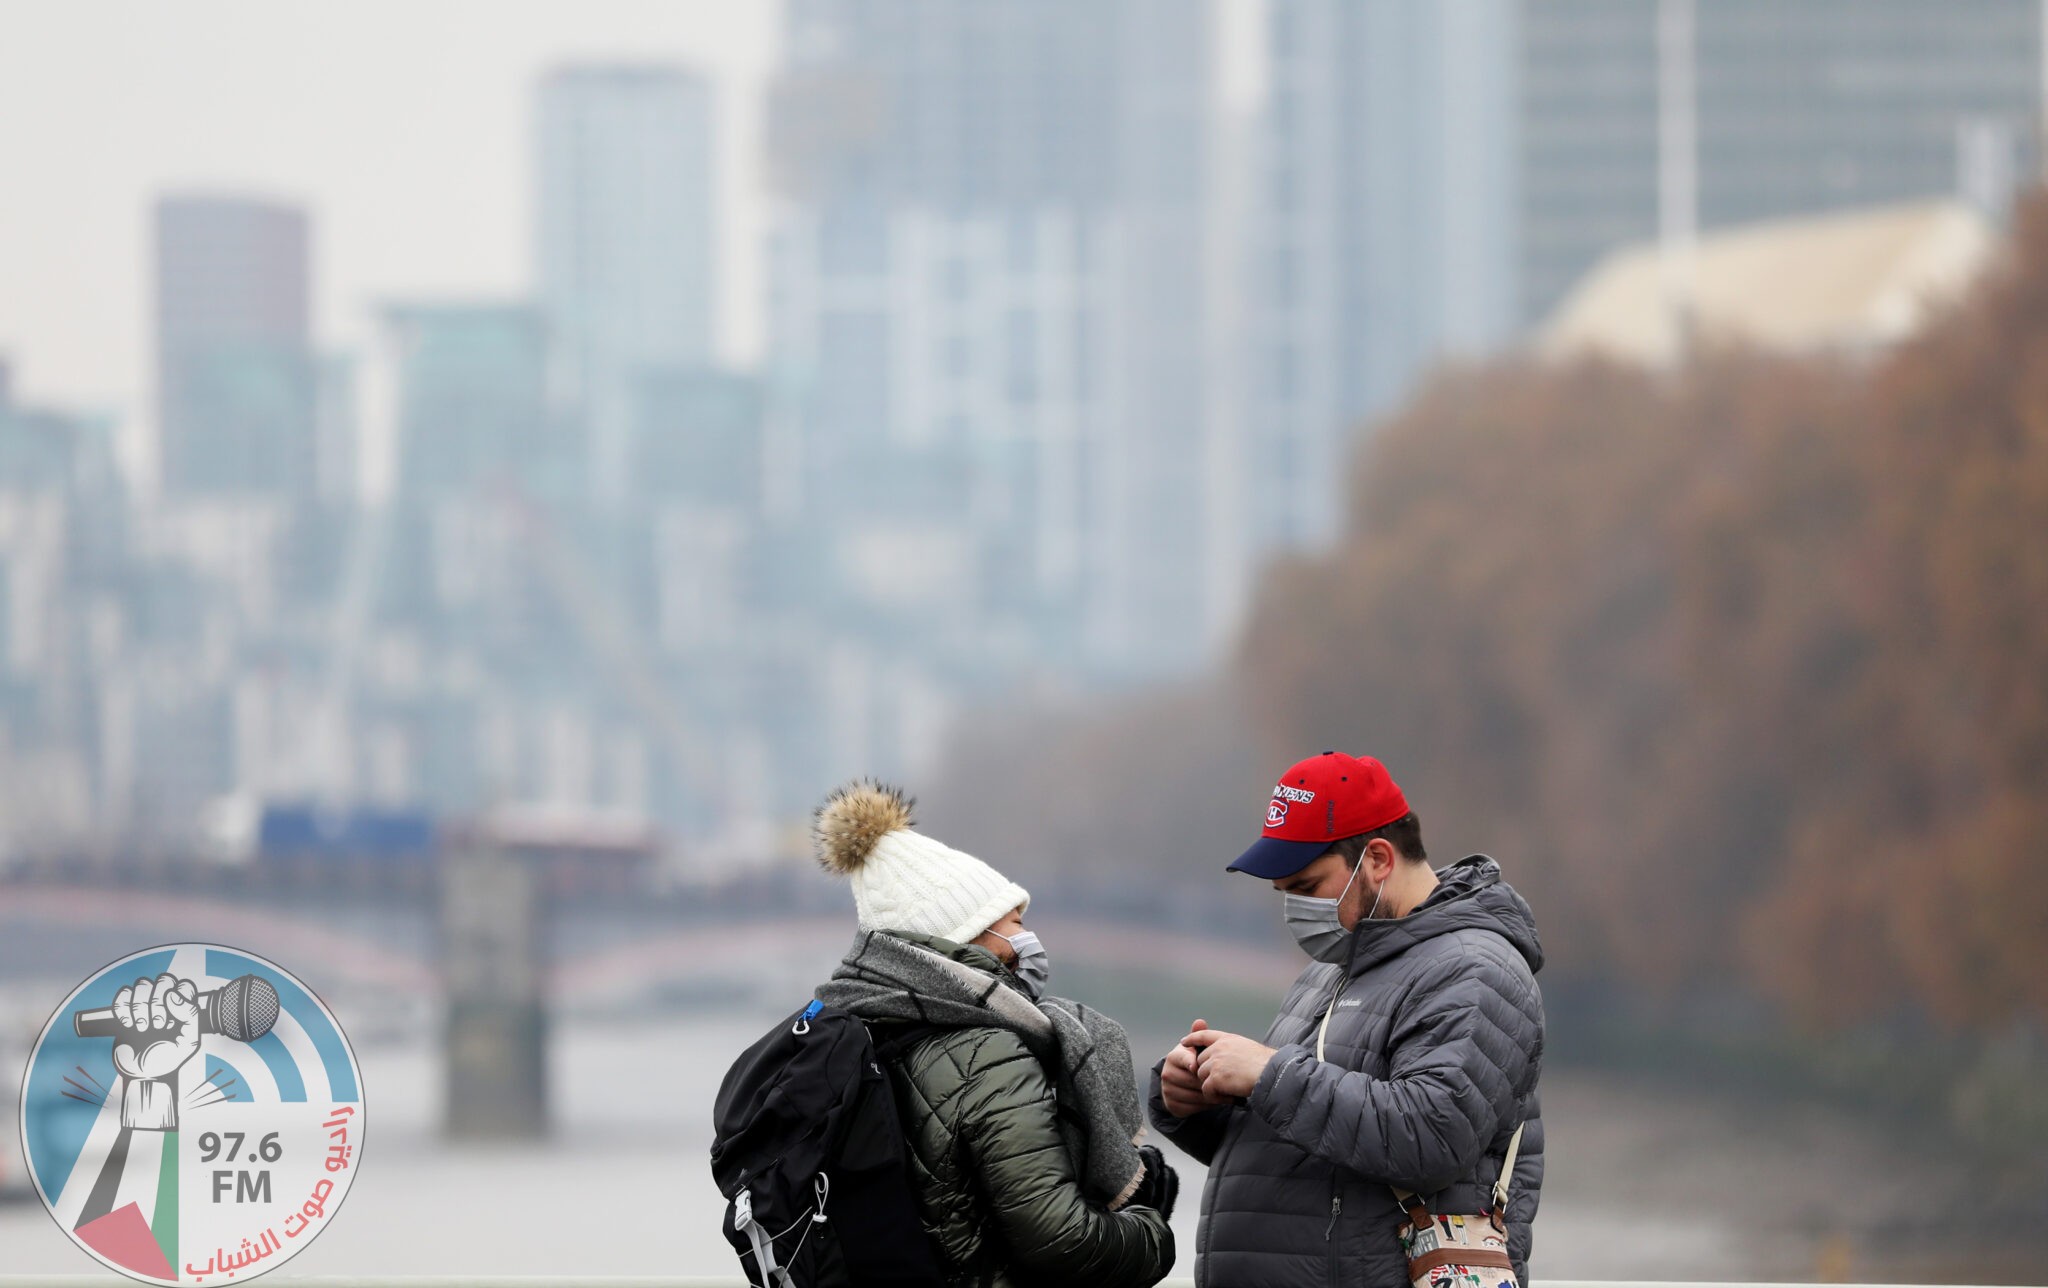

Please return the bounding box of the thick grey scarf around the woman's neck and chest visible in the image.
[817,930,1145,1212]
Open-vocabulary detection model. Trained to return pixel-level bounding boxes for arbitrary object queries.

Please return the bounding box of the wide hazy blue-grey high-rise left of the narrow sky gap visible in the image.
[768,0,1219,688]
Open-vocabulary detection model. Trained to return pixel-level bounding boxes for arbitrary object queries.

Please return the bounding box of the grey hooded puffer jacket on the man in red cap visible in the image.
[1151,854,1542,1288]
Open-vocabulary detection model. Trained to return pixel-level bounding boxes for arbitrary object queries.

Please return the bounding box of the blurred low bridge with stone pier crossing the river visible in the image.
[0,868,1298,1141]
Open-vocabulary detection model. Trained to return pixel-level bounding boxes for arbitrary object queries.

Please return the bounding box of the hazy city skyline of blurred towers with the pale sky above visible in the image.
[0,0,2042,856]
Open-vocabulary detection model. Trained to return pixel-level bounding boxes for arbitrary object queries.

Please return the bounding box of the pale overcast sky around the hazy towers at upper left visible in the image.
[0,0,1257,428]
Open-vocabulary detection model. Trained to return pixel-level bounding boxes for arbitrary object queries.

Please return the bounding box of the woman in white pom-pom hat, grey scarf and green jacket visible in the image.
[815,782,1178,1288]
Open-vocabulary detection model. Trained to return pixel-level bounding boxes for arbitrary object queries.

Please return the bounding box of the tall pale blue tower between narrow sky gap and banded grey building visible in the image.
[1233,0,1522,553]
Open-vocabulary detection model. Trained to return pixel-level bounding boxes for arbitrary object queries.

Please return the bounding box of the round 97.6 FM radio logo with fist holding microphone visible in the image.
[20,944,362,1284]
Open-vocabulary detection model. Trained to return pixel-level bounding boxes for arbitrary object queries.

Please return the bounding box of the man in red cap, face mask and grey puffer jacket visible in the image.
[1151,752,1544,1288]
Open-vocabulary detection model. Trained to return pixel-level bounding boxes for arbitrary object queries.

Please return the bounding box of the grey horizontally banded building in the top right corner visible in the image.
[1518,0,2042,321]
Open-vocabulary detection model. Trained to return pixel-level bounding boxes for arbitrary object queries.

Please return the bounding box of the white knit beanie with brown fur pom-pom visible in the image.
[813,780,1030,944]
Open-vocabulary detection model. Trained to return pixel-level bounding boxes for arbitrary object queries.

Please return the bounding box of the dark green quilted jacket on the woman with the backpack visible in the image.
[874,940,1174,1288]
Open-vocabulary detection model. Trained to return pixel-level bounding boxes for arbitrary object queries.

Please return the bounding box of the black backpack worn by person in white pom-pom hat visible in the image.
[711,1001,944,1288]
